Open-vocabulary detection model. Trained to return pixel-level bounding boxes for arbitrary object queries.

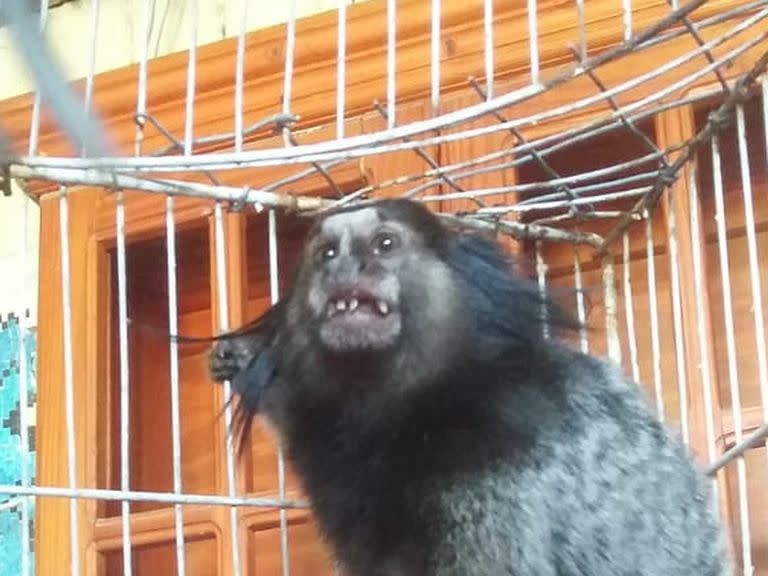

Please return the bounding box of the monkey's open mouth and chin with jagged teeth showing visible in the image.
[320,289,401,353]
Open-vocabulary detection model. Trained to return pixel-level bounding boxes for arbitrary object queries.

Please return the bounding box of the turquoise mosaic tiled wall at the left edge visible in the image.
[0,314,37,576]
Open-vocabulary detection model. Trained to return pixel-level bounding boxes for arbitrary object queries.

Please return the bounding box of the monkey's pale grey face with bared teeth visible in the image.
[297,207,460,354]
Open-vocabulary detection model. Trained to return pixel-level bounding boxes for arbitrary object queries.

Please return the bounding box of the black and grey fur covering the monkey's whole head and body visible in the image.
[211,201,731,576]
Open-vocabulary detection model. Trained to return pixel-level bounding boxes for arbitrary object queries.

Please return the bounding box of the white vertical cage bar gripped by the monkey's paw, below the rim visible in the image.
[214,202,241,576]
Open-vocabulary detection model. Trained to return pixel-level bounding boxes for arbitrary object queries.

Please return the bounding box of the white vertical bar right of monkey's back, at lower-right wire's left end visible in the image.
[688,164,719,506]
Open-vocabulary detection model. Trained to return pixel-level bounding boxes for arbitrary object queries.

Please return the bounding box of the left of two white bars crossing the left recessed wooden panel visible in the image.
[115,190,133,576]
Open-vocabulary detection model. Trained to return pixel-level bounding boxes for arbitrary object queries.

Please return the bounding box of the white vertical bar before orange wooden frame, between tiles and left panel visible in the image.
[59,187,80,575]
